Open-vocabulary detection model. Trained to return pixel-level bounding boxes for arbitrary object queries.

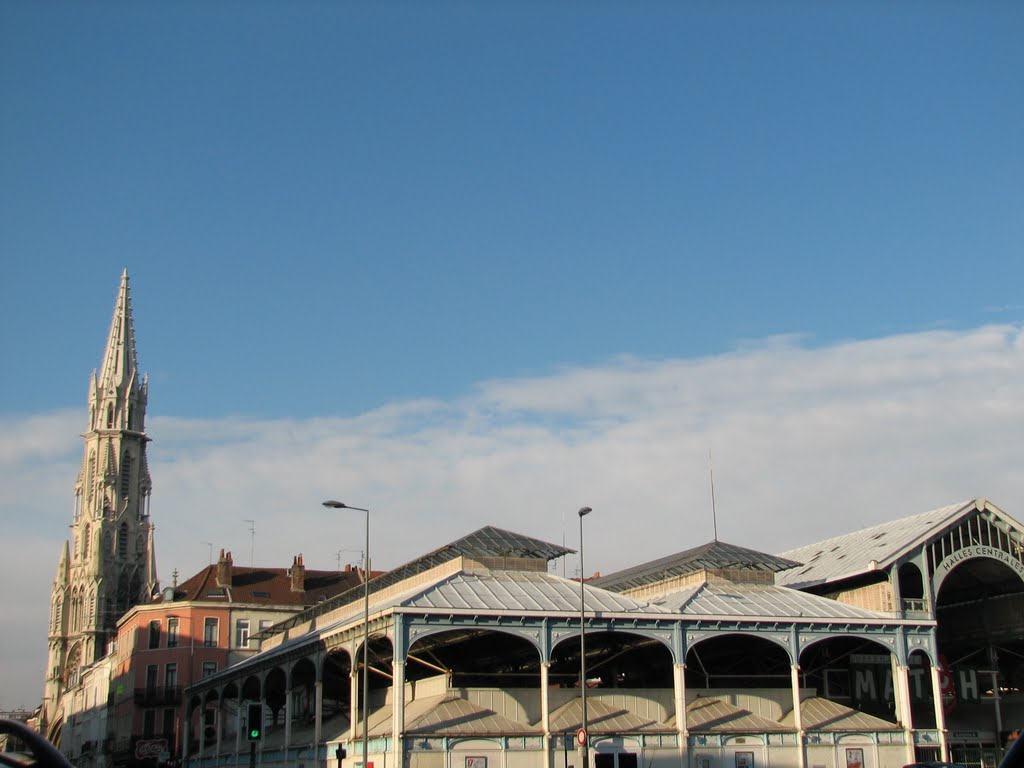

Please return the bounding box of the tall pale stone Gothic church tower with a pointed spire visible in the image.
[42,270,159,732]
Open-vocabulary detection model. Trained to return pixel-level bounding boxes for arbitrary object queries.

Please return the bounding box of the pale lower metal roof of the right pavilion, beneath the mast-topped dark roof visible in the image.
[654,582,892,622]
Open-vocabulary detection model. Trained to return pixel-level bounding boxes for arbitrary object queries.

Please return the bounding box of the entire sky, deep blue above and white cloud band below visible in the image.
[0,2,1024,706]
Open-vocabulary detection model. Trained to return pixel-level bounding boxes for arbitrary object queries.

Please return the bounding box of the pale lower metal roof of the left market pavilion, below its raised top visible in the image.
[398,570,666,613]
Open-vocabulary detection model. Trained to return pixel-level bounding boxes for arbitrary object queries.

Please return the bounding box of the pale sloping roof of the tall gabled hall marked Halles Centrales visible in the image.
[776,500,983,589]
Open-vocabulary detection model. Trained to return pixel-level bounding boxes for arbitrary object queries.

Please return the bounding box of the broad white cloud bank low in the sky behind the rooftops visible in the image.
[0,326,1024,706]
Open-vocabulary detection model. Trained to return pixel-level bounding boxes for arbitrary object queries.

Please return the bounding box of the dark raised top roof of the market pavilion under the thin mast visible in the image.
[592,541,800,592]
